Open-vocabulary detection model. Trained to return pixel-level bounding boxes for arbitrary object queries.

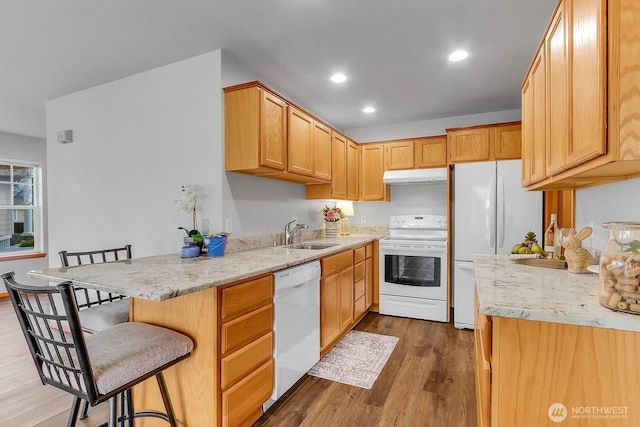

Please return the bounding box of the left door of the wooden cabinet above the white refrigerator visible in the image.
[447,128,491,163]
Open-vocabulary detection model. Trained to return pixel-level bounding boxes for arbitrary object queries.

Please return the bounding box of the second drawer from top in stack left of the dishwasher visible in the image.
[220,304,273,354]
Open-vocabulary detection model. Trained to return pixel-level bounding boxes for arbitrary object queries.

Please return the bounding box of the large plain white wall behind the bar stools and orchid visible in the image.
[47,50,223,266]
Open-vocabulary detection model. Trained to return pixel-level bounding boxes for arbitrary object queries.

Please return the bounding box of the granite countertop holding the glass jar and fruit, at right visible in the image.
[473,255,640,332]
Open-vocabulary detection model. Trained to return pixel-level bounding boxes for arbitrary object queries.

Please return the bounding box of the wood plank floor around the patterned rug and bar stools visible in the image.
[0,299,476,427]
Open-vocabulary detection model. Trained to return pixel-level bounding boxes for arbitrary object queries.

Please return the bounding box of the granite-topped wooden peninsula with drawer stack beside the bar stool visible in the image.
[28,235,377,427]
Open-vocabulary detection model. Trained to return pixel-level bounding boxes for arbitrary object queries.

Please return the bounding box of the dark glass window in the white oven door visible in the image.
[384,255,440,287]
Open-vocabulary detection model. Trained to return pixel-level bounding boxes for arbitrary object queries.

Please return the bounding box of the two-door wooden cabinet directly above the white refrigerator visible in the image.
[447,122,522,163]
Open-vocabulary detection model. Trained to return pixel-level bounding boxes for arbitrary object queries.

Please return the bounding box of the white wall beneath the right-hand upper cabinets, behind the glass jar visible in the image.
[576,178,640,251]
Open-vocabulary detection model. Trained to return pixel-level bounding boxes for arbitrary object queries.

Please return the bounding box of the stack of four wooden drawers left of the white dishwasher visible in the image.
[217,275,273,427]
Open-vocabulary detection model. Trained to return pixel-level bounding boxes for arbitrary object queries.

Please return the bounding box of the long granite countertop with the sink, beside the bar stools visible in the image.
[27,234,384,301]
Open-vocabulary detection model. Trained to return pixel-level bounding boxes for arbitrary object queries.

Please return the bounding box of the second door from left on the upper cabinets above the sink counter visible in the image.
[287,106,314,176]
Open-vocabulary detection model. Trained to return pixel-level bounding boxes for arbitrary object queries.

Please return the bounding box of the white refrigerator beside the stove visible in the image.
[453,160,544,329]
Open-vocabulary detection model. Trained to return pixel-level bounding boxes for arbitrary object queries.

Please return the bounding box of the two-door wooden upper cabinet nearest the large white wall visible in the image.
[224,82,328,183]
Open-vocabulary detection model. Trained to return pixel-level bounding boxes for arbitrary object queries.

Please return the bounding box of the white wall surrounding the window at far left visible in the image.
[0,132,48,292]
